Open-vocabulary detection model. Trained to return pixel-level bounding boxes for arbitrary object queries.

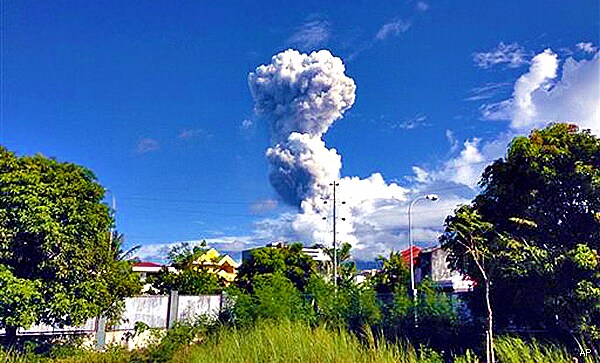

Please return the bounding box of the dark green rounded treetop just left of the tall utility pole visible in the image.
[236,243,317,293]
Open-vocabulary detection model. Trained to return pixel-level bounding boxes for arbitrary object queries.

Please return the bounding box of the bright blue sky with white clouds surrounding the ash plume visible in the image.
[0,0,600,260]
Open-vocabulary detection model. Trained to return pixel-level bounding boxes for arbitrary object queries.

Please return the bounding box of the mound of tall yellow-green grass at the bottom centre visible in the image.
[179,321,450,363]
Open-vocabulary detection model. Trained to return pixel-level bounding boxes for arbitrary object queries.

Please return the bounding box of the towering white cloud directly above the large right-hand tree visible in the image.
[481,49,600,134]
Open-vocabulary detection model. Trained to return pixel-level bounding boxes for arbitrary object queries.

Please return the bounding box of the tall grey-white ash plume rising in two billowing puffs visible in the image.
[248,50,356,207]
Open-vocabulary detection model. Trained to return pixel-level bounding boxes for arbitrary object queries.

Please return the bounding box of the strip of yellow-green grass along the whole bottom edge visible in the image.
[0,321,593,363]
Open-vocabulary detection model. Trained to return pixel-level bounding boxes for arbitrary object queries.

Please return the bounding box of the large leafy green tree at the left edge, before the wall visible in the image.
[0,147,140,341]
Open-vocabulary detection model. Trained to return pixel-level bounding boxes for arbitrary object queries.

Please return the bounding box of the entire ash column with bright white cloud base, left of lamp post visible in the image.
[248,50,424,257]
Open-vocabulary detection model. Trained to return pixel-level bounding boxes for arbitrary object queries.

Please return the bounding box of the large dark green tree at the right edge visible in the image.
[442,124,600,352]
